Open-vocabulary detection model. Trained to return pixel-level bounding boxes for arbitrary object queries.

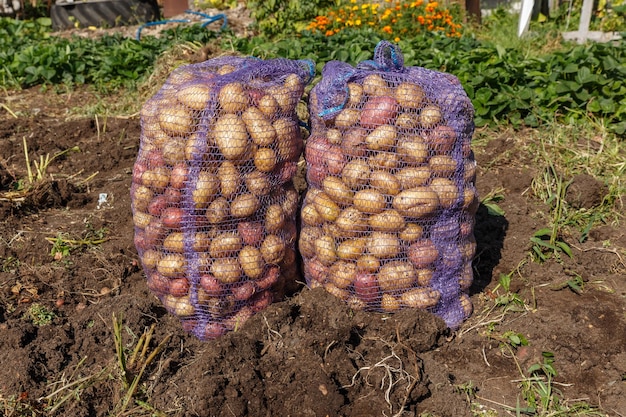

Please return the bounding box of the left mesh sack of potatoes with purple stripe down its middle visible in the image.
[131,57,313,340]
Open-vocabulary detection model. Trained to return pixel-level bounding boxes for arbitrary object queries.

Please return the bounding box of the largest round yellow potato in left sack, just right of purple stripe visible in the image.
[212,114,250,161]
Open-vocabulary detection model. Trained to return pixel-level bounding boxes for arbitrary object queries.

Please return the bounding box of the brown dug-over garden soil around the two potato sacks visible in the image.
[0,90,626,417]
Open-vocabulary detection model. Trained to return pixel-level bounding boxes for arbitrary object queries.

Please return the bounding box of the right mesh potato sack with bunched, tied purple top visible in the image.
[299,41,478,328]
